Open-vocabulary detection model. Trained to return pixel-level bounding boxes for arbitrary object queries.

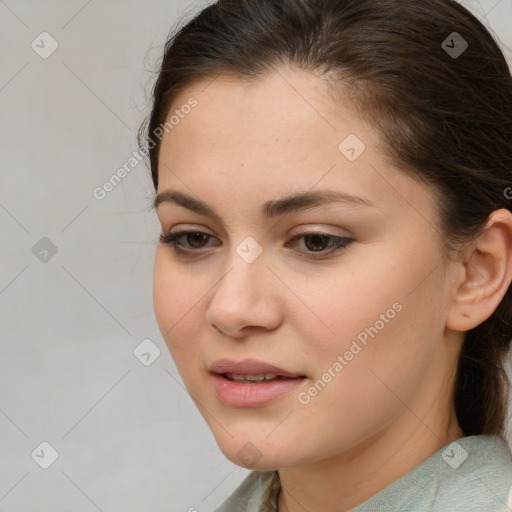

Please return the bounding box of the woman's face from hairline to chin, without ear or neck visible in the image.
[154,68,459,470]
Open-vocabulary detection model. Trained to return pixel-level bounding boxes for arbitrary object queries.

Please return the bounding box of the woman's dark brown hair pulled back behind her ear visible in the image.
[139,0,512,436]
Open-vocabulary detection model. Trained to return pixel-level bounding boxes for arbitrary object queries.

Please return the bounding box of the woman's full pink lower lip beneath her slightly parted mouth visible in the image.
[212,373,306,407]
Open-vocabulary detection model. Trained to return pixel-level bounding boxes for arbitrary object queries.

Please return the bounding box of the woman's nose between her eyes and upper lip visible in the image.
[206,251,282,338]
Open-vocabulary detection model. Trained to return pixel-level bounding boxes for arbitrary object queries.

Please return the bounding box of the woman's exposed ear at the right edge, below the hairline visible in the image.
[446,208,512,331]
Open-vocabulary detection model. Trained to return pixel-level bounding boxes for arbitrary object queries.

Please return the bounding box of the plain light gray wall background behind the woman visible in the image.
[0,0,512,512]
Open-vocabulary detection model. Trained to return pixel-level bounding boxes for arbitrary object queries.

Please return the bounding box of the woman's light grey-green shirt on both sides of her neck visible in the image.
[215,435,512,512]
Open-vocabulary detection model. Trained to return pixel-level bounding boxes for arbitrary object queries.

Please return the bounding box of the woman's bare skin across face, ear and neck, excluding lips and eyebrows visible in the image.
[153,67,512,512]
